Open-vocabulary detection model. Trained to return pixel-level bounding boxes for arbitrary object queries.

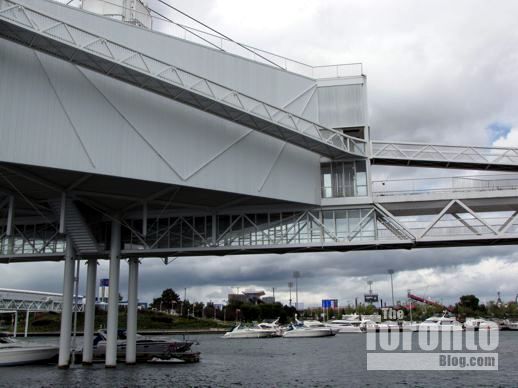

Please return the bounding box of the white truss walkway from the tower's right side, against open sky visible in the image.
[371,141,518,171]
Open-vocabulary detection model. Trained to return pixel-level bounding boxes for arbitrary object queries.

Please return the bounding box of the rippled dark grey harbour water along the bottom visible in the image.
[0,332,518,387]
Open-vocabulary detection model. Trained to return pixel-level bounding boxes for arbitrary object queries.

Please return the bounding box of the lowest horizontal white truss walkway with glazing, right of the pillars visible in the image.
[114,200,518,257]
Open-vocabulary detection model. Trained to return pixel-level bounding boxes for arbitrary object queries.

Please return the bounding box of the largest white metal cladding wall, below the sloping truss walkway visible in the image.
[0,40,320,204]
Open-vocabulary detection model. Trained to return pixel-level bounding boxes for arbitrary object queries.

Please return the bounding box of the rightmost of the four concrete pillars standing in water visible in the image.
[126,258,139,364]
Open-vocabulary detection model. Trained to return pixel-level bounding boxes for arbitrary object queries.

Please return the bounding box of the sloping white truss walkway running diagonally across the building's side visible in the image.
[0,0,366,159]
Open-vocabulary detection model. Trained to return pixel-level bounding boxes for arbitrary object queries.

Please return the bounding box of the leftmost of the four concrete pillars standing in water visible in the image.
[58,237,74,368]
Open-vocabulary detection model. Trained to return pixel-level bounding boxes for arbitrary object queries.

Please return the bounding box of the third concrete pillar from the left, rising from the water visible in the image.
[105,221,121,368]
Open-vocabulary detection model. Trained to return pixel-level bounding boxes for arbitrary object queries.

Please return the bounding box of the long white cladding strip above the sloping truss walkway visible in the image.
[13,0,315,112]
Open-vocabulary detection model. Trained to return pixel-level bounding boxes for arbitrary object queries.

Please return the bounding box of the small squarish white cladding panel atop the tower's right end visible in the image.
[318,84,367,128]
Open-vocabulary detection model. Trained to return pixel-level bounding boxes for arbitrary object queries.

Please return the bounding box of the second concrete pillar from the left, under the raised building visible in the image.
[83,259,97,365]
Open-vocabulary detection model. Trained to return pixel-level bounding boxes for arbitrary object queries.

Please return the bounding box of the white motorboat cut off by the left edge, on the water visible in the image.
[0,337,59,366]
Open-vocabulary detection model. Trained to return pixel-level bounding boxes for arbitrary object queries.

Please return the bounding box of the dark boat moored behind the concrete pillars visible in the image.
[94,330,194,361]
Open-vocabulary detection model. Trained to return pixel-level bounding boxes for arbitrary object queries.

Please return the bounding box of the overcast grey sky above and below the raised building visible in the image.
[0,0,518,305]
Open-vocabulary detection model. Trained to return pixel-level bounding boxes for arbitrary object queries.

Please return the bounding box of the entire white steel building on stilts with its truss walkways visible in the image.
[0,0,518,367]
